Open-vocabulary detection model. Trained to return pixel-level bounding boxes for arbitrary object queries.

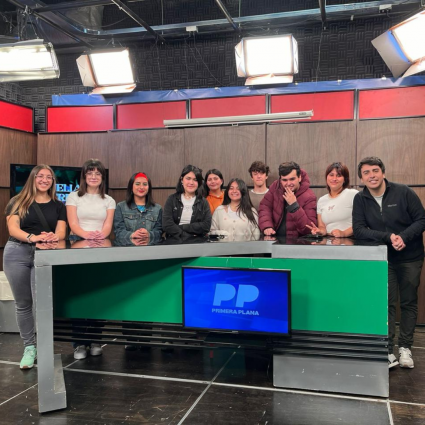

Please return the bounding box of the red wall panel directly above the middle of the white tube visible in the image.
[191,96,266,118]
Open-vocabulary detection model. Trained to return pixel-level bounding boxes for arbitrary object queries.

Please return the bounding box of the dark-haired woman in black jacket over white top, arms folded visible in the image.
[162,165,211,238]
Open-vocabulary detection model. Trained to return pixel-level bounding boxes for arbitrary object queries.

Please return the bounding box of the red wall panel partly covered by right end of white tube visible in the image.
[270,91,354,121]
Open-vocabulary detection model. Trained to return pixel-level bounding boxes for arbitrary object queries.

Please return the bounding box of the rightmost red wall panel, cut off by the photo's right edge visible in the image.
[359,86,425,119]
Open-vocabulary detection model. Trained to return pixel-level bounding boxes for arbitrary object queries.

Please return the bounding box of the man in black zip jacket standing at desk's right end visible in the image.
[353,157,425,368]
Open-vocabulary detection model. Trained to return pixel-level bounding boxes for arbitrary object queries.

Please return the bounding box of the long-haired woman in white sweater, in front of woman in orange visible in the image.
[211,179,260,238]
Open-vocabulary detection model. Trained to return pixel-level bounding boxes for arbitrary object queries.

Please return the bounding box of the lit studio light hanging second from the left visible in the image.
[77,48,136,94]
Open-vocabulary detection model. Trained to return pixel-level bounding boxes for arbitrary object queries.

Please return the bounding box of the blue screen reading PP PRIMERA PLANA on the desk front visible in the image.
[182,266,291,335]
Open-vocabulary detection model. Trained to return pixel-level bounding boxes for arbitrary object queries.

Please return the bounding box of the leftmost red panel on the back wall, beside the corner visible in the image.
[47,105,114,133]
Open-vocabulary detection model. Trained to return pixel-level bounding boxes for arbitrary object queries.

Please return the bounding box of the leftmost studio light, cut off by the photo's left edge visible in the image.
[0,39,60,83]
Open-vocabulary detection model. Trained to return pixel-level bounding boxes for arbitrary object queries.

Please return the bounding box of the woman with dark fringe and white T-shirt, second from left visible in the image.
[66,159,116,360]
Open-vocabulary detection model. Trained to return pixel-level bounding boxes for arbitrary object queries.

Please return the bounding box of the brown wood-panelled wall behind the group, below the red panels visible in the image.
[0,111,425,323]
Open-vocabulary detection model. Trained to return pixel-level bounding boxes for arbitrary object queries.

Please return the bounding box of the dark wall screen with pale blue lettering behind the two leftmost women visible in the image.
[10,164,108,203]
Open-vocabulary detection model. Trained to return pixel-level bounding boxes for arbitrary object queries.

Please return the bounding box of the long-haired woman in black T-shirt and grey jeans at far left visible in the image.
[3,165,66,369]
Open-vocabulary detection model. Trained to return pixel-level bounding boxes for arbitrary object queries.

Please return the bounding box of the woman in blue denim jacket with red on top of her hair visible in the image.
[114,173,162,245]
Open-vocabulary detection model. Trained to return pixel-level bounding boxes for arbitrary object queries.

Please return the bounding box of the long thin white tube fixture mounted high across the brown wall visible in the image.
[164,111,314,128]
